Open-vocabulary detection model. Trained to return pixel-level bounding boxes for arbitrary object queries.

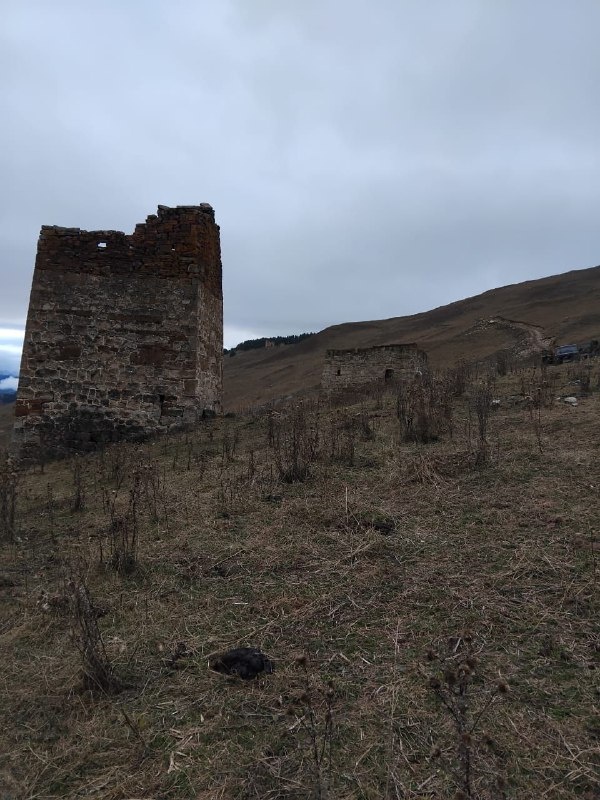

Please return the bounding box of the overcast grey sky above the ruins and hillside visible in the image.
[0,0,600,369]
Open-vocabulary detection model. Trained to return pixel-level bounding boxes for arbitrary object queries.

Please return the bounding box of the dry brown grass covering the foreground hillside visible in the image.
[0,368,600,800]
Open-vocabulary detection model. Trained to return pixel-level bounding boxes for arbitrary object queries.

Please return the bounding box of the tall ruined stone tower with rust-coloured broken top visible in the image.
[13,204,223,458]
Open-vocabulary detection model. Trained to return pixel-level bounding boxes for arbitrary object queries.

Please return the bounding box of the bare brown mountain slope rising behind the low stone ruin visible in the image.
[224,267,600,409]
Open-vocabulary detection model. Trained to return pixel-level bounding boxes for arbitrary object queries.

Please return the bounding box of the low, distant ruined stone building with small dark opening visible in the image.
[321,344,427,392]
